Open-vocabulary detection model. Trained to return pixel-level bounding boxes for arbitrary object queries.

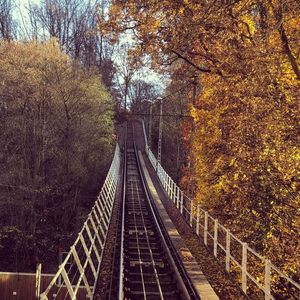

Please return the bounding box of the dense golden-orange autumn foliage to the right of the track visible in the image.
[110,0,300,292]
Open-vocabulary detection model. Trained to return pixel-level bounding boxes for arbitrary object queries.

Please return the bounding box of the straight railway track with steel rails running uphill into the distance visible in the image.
[107,123,199,300]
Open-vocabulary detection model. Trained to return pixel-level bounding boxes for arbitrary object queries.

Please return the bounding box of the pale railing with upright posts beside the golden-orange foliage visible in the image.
[145,144,300,300]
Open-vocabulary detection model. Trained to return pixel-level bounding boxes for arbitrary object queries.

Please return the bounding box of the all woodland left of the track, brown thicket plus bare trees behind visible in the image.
[0,1,116,272]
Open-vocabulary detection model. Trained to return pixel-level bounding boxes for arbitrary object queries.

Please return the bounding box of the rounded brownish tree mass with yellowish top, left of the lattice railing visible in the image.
[0,40,113,270]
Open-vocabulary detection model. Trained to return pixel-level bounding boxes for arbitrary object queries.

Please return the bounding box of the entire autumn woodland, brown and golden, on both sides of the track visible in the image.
[0,0,300,292]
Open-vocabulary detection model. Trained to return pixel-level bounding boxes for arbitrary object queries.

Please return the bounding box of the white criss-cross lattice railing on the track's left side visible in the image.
[40,144,120,300]
